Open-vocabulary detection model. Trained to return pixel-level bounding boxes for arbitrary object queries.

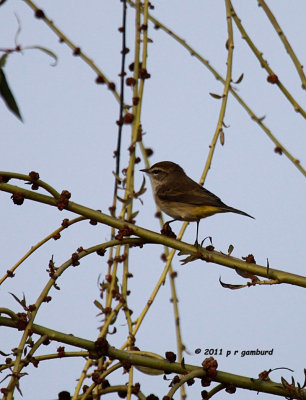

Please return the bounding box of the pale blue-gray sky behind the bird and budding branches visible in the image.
[0,0,306,400]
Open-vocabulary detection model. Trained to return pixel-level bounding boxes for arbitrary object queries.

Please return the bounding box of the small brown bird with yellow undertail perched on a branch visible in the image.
[141,161,254,245]
